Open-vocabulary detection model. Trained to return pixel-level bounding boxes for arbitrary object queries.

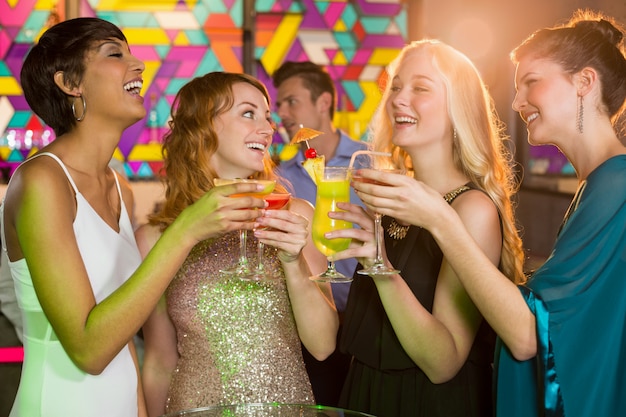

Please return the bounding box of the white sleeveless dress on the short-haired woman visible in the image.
[0,153,141,417]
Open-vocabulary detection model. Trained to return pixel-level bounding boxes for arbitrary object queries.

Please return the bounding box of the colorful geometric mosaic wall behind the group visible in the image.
[0,0,407,180]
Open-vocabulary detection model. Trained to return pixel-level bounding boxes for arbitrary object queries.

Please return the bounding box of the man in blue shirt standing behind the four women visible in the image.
[272,61,367,406]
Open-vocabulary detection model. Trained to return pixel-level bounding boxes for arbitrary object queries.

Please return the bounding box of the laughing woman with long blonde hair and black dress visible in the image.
[328,40,523,417]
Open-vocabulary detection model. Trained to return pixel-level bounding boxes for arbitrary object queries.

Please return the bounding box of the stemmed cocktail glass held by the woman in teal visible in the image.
[353,151,404,276]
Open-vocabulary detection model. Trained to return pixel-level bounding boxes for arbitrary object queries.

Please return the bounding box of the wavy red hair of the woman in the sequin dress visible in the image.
[149,72,283,228]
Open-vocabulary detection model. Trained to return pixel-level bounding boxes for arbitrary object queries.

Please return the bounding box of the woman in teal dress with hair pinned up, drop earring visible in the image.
[364,11,626,417]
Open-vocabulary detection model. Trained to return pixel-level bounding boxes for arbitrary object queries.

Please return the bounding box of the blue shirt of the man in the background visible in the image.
[278,131,367,312]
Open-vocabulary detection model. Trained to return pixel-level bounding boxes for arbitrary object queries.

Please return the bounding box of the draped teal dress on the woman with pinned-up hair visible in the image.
[495,155,626,417]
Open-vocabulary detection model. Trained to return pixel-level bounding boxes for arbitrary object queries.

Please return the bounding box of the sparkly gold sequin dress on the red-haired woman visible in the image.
[166,232,314,413]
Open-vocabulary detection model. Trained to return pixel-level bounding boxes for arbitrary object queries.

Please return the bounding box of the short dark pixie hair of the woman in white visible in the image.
[20,17,127,136]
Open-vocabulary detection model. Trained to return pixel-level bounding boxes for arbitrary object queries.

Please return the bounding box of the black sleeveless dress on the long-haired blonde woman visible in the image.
[339,187,495,417]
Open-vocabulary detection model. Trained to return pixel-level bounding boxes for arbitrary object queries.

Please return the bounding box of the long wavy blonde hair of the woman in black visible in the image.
[369,39,524,283]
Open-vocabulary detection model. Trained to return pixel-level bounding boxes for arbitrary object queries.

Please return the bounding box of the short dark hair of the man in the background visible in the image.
[272,61,337,119]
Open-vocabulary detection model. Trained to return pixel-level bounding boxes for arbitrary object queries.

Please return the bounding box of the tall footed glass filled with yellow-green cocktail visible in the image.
[309,167,352,282]
